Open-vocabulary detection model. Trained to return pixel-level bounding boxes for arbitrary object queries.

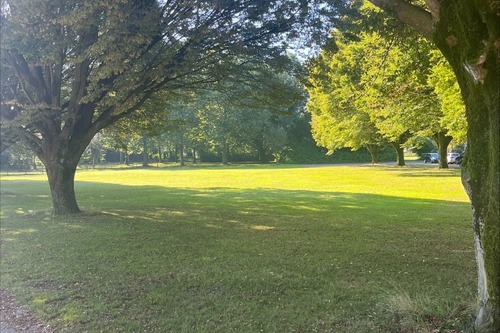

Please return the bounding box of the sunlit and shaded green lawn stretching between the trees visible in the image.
[0,165,476,332]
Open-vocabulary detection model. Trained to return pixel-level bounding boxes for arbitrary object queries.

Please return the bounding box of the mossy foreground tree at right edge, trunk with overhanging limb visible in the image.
[370,0,500,332]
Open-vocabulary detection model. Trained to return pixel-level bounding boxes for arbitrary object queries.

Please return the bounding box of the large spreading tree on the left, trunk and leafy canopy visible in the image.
[0,0,308,215]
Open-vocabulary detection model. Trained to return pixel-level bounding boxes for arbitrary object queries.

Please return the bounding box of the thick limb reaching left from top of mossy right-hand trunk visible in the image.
[369,0,434,40]
